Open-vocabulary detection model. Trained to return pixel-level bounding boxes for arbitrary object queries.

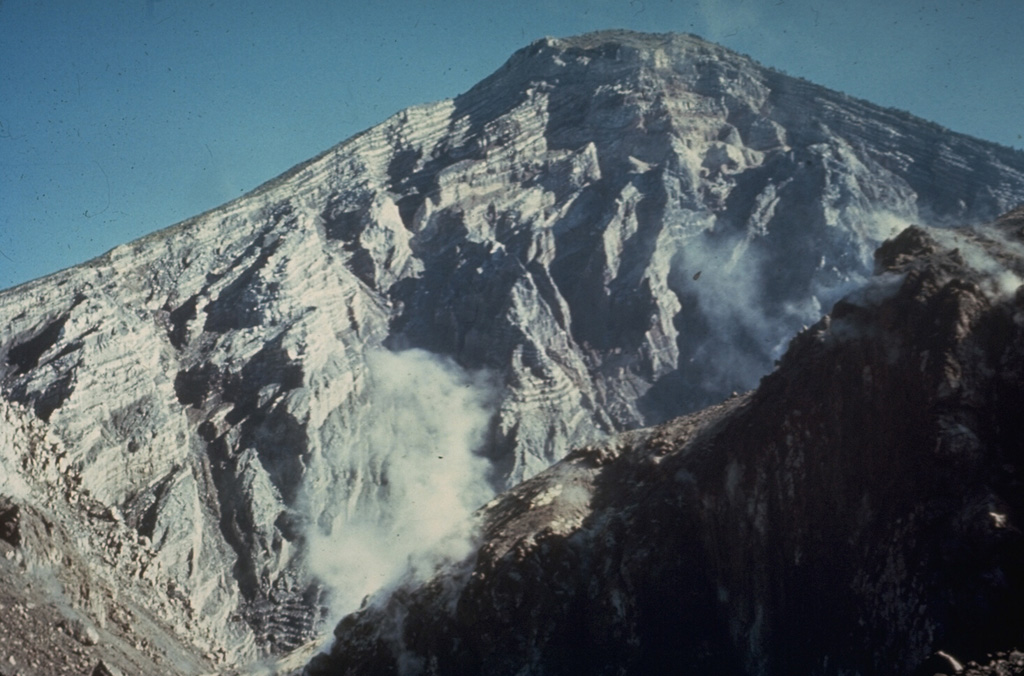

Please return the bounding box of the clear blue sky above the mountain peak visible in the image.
[0,0,1024,288]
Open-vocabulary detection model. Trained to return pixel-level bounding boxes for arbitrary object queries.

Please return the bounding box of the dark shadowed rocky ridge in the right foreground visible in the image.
[309,216,1024,675]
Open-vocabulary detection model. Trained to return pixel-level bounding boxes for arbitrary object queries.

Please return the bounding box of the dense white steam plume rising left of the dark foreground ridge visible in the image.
[307,349,496,618]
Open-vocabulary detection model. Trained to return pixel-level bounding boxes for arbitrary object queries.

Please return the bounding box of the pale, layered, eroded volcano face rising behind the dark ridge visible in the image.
[0,32,1024,661]
